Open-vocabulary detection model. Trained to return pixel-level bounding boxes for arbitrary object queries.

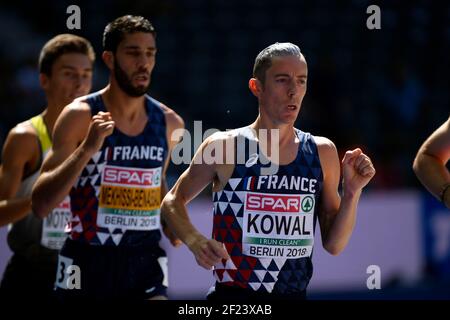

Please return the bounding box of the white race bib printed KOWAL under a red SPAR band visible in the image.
[242,192,315,259]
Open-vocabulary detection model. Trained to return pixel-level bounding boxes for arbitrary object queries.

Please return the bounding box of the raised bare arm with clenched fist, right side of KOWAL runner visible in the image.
[317,137,375,255]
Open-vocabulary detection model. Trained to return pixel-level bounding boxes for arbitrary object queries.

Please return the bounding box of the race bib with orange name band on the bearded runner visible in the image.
[97,165,161,231]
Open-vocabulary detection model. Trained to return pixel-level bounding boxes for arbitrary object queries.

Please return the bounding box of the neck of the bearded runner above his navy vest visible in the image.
[102,81,145,119]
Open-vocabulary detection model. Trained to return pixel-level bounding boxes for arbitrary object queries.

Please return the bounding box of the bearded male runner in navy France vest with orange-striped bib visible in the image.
[33,15,183,300]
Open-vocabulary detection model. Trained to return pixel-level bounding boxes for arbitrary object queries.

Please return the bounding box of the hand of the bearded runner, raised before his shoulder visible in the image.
[83,111,114,153]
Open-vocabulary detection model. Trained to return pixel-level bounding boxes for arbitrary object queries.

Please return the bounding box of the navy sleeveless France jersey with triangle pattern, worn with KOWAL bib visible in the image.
[213,127,323,294]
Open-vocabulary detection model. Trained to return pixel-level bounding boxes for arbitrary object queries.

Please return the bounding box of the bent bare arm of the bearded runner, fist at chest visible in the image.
[32,102,114,217]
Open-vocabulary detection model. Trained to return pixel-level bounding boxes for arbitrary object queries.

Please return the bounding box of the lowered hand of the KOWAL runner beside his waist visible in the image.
[189,236,230,270]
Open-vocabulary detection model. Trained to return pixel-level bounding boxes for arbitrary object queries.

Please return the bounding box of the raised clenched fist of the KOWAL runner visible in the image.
[342,148,375,193]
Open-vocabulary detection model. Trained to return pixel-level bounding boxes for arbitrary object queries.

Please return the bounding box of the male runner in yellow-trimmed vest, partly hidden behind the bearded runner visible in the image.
[0,34,95,298]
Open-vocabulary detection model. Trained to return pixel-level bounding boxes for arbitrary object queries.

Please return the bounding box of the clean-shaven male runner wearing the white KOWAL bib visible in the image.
[162,43,375,300]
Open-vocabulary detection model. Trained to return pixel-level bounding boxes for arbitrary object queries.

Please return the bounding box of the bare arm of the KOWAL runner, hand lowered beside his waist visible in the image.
[161,137,229,269]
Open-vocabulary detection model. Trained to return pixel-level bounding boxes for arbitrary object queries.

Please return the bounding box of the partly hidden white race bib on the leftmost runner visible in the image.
[41,197,72,250]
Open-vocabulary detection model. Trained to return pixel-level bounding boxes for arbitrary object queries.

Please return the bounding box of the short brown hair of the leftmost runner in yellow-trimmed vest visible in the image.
[39,33,95,76]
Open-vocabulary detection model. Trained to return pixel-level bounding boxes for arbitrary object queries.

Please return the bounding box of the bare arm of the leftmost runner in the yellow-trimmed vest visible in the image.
[0,125,39,226]
